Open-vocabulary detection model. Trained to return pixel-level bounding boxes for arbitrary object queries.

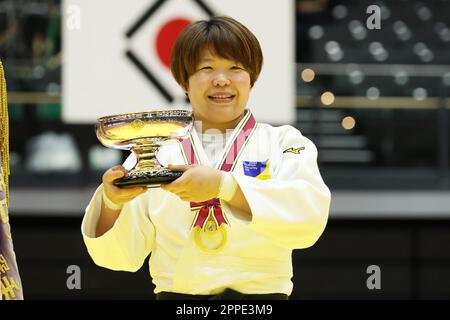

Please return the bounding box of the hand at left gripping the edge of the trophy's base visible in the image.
[102,166,147,205]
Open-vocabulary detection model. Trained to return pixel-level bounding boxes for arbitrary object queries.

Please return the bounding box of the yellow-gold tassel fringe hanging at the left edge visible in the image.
[0,61,9,206]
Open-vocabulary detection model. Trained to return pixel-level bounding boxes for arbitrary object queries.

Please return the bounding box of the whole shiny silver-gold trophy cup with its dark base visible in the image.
[95,110,193,188]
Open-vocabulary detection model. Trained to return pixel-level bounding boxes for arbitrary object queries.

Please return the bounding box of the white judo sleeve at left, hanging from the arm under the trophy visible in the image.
[81,185,155,272]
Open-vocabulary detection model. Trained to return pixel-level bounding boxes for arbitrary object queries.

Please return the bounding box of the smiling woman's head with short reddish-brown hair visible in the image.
[171,17,263,132]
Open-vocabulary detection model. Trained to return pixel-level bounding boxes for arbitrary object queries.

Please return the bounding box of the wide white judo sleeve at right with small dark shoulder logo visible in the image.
[232,126,331,249]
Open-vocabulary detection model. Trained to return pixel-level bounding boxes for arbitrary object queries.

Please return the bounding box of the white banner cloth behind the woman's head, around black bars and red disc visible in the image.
[62,0,295,124]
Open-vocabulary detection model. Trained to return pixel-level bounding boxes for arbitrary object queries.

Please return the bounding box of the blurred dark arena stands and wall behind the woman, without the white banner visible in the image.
[0,0,450,299]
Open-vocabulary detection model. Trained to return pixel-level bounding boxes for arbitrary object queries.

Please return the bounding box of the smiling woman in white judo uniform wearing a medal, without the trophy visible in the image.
[82,17,330,300]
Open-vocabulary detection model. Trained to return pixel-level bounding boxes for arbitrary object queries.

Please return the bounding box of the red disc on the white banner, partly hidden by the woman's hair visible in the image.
[156,18,191,69]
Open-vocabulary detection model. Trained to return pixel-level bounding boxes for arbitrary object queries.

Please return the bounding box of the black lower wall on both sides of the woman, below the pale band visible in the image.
[13,218,450,299]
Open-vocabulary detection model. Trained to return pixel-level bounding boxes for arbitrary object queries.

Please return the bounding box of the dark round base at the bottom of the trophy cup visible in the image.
[114,170,183,188]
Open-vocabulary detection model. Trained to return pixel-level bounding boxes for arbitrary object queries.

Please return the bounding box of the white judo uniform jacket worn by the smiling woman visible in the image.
[81,111,330,295]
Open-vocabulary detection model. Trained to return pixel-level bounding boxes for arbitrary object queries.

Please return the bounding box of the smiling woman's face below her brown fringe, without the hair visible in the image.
[185,49,251,127]
